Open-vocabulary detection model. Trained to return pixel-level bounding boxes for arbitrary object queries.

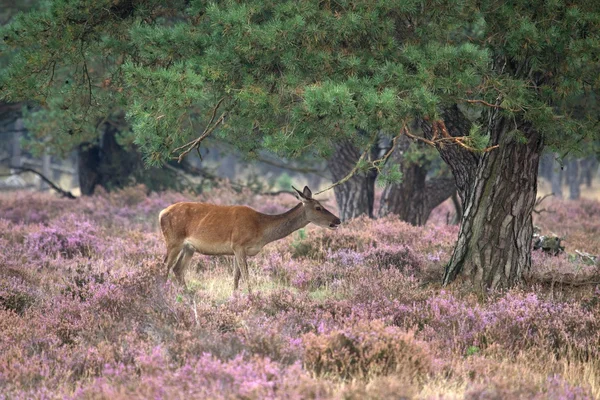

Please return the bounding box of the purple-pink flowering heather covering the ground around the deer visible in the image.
[0,186,600,399]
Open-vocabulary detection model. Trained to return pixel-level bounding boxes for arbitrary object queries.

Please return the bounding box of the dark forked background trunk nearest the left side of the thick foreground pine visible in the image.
[379,136,456,226]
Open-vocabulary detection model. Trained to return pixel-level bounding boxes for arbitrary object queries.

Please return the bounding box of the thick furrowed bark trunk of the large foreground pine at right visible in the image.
[426,106,543,291]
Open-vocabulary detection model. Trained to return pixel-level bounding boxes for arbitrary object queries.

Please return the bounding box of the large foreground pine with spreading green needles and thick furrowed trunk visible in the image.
[0,0,600,290]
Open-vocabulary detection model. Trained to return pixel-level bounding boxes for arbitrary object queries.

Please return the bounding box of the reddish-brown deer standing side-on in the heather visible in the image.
[158,186,341,293]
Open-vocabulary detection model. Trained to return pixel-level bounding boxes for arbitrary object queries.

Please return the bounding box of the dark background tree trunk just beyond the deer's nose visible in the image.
[327,141,377,221]
